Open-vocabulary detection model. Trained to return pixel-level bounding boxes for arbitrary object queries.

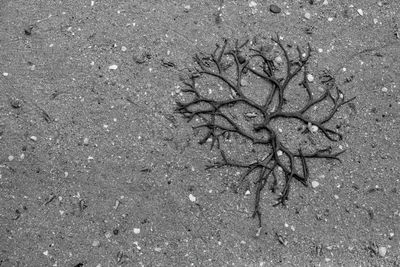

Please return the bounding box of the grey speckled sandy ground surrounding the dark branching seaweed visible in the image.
[0,0,400,267]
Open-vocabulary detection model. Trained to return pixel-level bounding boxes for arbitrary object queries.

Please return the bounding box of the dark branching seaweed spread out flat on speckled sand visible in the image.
[176,35,354,227]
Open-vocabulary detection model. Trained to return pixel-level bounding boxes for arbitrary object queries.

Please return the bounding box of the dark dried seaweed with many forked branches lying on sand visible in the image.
[176,35,354,227]
